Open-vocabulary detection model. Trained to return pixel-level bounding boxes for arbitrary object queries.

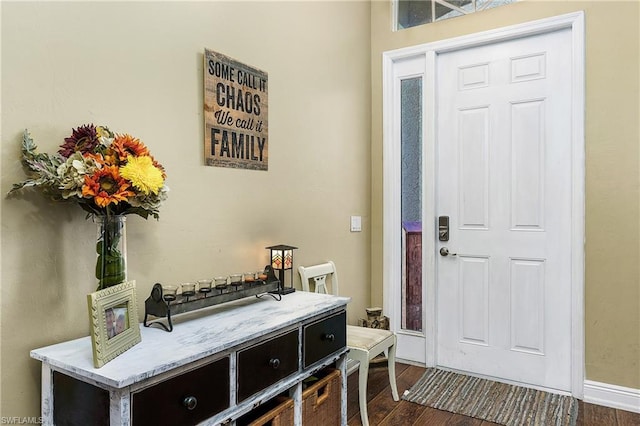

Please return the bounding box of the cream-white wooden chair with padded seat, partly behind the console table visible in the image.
[298,261,400,426]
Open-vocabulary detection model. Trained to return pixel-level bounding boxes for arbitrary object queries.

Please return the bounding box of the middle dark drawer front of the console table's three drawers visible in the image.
[238,330,298,402]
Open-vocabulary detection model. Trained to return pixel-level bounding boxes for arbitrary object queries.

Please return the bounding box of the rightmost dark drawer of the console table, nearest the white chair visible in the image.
[303,312,347,368]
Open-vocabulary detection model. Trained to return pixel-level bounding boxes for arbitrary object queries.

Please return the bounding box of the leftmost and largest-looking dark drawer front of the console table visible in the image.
[131,357,229,426]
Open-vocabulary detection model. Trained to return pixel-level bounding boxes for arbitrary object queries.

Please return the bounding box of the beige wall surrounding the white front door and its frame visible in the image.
[371,1,640,389]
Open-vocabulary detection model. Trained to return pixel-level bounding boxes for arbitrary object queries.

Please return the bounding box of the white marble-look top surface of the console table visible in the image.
[31,291,351,388]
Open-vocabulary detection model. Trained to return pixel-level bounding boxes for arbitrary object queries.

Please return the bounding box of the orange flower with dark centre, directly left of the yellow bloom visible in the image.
[82,166,135,207]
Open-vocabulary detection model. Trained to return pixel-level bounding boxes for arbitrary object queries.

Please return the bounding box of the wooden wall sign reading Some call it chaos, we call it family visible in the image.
[204,49,269,170]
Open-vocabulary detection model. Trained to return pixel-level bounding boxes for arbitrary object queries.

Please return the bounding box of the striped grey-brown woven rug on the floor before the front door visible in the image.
[402,368,578,426]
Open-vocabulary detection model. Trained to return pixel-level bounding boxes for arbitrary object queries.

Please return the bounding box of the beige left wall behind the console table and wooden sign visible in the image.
[0,1,371,416]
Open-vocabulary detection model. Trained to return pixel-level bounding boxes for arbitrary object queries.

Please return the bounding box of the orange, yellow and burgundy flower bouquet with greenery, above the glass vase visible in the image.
[9,124,168,219]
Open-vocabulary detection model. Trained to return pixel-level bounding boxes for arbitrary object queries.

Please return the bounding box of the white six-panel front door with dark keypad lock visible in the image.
[435,29,579,391]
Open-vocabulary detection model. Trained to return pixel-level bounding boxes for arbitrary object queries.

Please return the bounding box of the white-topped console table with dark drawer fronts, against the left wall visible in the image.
[31,292,350,426]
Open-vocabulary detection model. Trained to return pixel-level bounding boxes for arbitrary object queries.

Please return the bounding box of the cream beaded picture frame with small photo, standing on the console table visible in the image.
[87,281,141,368]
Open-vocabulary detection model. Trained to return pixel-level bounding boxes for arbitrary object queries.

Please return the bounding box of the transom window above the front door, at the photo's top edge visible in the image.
[393,0,516,30]
